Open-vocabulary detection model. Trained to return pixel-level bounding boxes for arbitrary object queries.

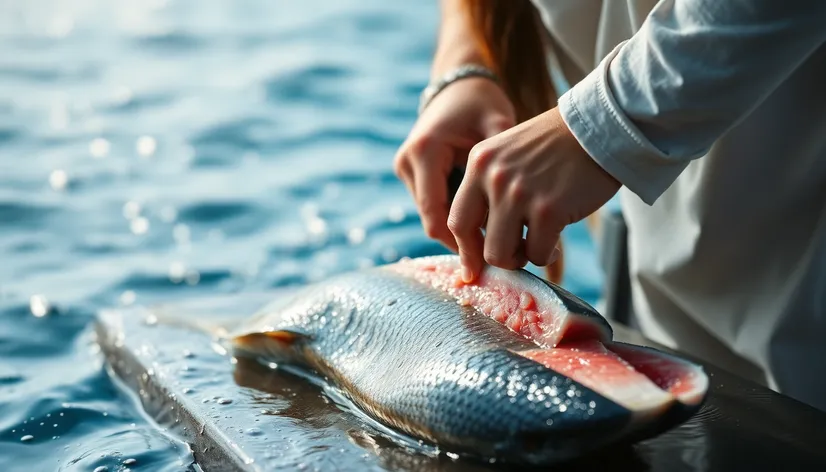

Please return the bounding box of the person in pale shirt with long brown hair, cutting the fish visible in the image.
[394,0,826,410]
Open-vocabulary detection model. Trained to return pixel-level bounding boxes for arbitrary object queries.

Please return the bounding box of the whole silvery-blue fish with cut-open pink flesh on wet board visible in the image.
[228,255,708,464]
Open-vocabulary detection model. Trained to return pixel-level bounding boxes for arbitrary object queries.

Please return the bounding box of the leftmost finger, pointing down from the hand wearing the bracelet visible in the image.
[413,146,457,250]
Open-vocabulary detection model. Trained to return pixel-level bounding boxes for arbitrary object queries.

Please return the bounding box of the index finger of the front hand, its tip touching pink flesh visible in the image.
[447,183,487,283]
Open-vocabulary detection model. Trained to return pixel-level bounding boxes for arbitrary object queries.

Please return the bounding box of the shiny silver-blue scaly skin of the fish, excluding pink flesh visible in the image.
[229,260,633,463]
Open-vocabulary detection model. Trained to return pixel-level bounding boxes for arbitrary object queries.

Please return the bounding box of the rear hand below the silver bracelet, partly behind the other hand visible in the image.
[394,77,516,251]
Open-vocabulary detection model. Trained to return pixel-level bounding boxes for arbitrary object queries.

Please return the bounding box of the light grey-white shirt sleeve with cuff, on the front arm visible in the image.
[559,0,826,204]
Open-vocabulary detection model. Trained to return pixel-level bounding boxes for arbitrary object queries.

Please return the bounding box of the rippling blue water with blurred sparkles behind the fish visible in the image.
[0,0,600,471]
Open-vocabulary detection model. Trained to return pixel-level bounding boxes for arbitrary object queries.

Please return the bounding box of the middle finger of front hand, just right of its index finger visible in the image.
[484,201,527,269]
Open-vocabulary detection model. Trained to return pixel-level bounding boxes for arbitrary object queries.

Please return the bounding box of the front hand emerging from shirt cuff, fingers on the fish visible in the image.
[448,108,620,282]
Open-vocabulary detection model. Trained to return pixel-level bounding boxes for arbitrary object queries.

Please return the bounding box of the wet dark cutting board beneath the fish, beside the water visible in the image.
[96,292,826,472]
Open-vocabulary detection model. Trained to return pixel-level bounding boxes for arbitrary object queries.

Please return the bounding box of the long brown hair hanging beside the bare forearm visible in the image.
[463,0,557,122]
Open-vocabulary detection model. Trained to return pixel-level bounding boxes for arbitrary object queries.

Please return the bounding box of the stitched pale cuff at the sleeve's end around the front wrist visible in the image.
[559,43,688,205]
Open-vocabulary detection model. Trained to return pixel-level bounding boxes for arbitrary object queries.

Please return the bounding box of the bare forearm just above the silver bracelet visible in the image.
[431,0,484,79]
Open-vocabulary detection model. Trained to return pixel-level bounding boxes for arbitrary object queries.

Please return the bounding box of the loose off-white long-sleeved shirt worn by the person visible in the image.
[532,0,826,409]
